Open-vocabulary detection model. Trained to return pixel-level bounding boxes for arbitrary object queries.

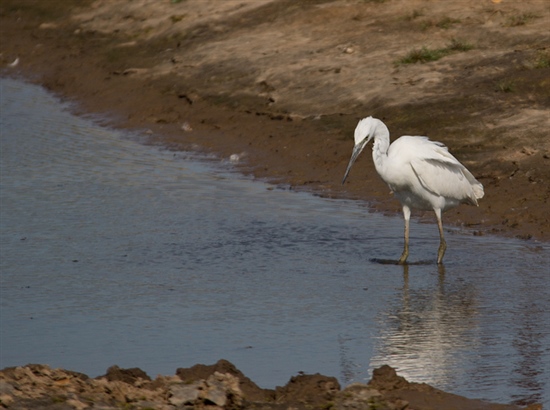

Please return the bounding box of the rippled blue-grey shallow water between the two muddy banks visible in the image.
[0,79,550,405]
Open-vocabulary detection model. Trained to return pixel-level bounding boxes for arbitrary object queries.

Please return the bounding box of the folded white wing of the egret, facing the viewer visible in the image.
[390,137,483,205]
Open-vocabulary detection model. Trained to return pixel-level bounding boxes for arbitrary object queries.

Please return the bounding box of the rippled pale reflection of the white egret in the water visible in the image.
[369,262,477,388]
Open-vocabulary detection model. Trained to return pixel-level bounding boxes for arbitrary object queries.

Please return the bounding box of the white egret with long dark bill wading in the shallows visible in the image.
[342,117,484,264]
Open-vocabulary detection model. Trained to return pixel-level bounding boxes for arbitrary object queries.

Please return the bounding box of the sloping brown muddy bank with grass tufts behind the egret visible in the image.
[0,0,550,240]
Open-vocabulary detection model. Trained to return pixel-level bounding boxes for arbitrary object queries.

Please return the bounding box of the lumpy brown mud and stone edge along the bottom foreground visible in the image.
[0,360,542,410]
